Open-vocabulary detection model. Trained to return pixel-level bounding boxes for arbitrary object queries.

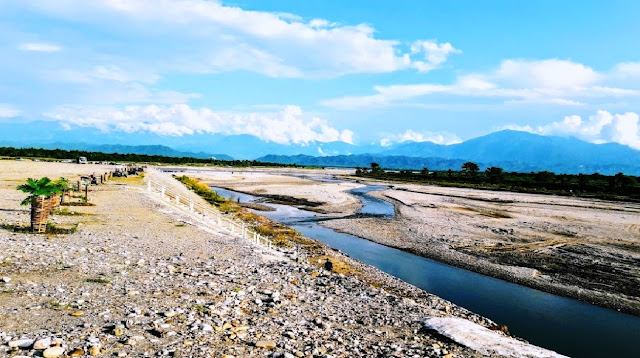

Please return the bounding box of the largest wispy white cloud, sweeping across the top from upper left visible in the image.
[12,0,459,78]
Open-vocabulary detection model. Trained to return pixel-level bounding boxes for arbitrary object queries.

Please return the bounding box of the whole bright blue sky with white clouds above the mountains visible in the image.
[0,0,640,149]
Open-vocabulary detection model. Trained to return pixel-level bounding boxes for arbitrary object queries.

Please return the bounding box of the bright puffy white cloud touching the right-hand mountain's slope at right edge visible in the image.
[503,110,640,149]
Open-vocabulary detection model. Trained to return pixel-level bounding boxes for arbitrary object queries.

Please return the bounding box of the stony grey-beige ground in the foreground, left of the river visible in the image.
[0,162,554,357]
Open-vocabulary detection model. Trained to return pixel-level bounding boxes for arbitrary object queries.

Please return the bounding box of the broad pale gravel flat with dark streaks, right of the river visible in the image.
[323,182,640,315]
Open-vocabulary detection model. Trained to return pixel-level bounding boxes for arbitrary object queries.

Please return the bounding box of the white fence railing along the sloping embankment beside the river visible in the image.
[147,179,272,249]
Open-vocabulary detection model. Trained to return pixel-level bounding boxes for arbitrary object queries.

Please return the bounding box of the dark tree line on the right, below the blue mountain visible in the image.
[355,162,640,200]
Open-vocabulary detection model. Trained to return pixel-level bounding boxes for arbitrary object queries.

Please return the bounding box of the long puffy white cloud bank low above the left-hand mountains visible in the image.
[45,104,353,144]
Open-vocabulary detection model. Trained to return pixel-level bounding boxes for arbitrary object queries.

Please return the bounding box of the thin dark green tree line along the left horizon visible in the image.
[0,147,297,167]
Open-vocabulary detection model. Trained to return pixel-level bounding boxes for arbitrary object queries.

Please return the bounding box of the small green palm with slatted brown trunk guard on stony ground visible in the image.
[18,177,60,233]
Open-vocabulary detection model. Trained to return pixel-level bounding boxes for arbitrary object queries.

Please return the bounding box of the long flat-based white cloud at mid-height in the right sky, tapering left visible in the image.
[322,59,640,109]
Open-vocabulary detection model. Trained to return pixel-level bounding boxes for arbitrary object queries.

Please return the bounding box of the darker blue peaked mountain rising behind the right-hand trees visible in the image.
[259,131,640,175]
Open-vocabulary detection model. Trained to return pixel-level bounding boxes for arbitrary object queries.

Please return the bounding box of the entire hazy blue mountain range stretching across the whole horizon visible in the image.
[0,123,640,175]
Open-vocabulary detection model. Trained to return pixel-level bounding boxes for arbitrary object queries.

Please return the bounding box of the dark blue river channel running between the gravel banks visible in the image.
[212,186,640,357]
